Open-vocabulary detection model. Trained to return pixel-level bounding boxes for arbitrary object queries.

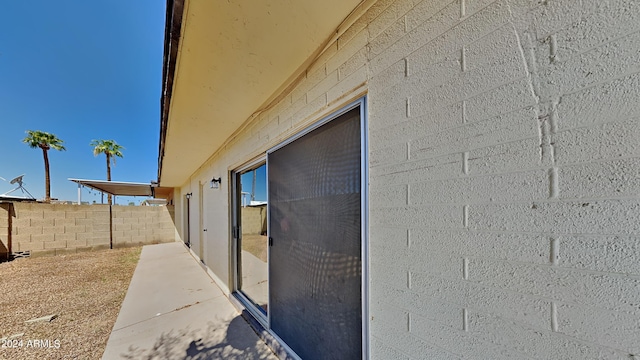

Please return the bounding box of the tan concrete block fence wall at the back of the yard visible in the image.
[0,203,175,258]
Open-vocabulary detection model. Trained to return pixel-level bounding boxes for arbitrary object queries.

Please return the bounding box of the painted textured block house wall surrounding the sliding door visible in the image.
[179,0,640,359]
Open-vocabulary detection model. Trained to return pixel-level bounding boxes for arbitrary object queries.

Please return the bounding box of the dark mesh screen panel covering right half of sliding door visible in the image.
[267,107,362,360]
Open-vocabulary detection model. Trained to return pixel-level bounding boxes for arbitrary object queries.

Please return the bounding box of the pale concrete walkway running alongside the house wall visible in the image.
[102,243,277,360]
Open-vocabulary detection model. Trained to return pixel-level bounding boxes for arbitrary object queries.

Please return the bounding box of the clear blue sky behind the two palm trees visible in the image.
[0,0,166,203]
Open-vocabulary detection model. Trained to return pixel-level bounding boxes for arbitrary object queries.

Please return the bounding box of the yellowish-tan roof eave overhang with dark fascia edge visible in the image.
[158,0,376,187]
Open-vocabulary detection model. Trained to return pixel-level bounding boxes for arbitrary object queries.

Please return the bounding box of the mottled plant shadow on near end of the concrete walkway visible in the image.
[121,316,274,360]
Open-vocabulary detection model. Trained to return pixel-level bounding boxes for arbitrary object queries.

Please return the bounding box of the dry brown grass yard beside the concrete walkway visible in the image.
[0,248,140,359]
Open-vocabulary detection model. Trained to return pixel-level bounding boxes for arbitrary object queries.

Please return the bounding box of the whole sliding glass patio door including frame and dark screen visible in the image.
[231,100,368,360]
